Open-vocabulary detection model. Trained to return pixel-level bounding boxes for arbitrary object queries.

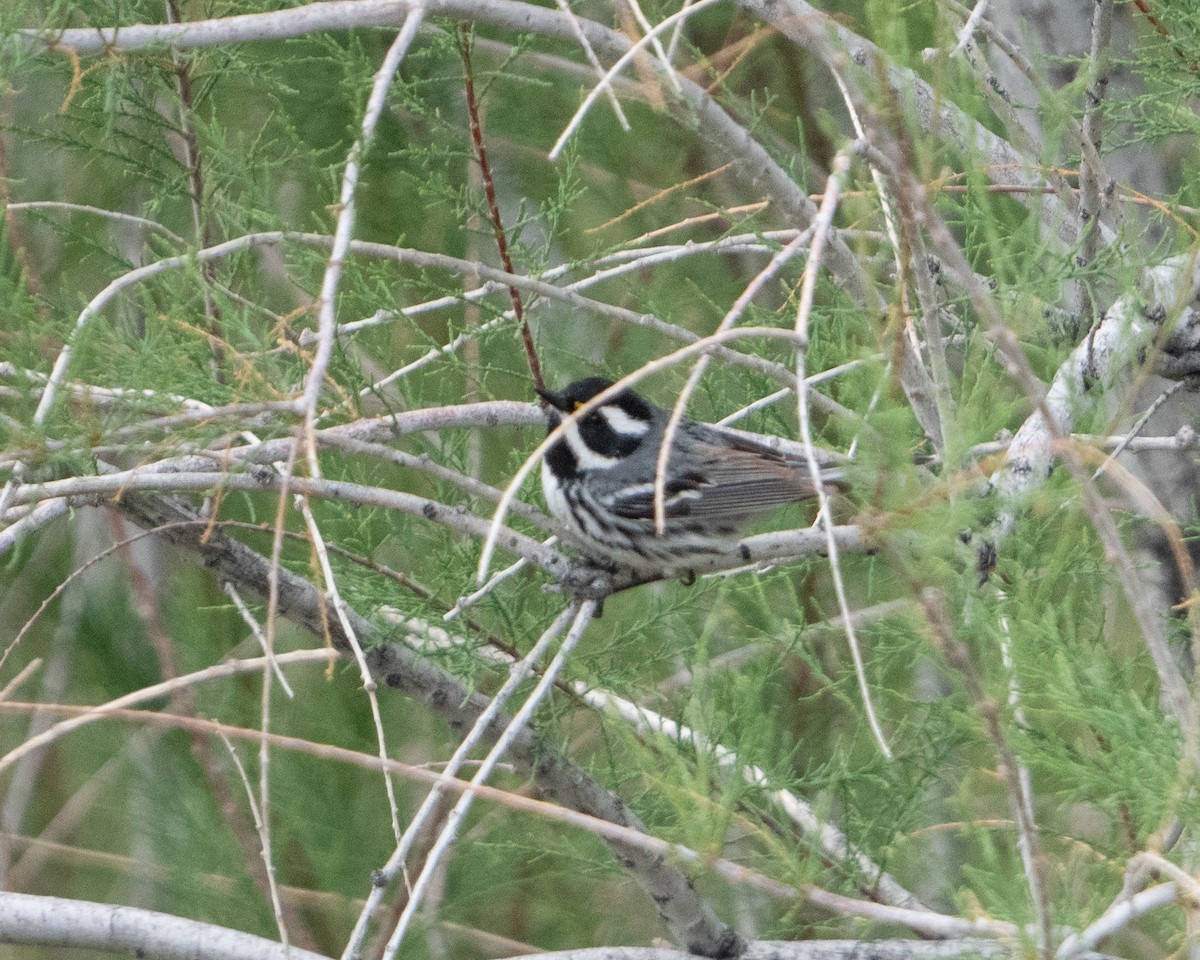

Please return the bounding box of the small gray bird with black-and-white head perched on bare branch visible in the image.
[538,377,841,576]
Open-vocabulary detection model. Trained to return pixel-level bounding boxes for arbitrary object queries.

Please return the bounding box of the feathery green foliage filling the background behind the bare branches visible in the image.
[0,0,1200,956]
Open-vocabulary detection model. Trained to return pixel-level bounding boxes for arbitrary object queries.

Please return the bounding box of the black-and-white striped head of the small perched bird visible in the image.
[538,377,654,475]
